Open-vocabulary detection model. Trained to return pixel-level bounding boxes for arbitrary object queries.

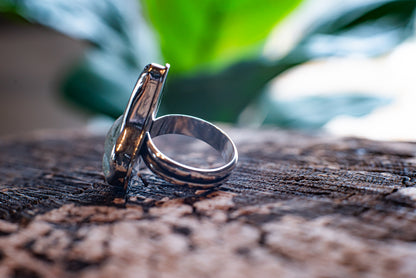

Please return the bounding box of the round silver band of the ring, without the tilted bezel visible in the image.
[141,115,238,188]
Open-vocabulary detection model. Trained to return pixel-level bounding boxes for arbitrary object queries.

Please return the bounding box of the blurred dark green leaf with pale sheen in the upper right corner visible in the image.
[289,0,416,61]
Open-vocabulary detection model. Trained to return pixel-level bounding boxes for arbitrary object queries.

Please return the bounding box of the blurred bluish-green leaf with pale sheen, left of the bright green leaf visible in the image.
[0,0,161,117]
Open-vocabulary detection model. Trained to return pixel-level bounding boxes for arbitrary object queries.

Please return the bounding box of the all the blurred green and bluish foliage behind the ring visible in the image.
[0,0,416,127]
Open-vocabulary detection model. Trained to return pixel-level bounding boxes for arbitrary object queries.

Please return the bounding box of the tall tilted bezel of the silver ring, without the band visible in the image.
[103,63,170,187]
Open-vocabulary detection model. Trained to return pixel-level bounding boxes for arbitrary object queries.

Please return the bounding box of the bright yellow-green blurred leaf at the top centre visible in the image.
[142,0,301,73]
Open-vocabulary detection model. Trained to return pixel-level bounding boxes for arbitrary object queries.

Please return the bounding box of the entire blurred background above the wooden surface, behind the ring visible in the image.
[0,0,416,140]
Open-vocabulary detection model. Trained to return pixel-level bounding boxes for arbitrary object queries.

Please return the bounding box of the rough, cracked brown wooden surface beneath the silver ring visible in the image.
[0,129,416,277]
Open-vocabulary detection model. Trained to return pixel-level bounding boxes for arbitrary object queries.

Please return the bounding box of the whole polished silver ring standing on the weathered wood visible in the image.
[103,64,238,188]
